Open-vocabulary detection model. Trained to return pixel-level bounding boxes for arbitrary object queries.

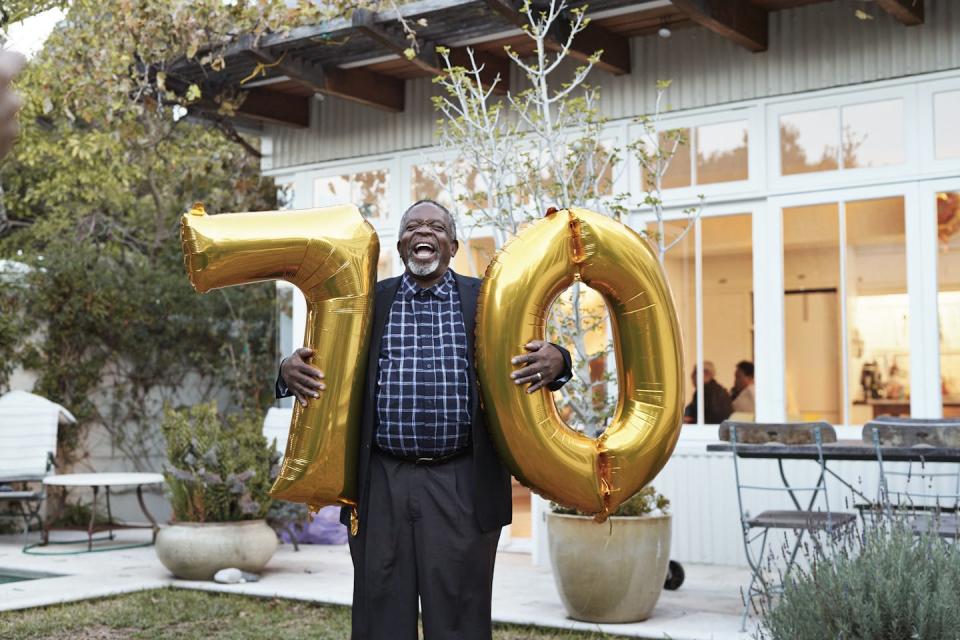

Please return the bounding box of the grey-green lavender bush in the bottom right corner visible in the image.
[761,524,960,640]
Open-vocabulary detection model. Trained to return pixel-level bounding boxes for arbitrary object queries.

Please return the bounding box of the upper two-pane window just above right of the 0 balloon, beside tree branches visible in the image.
[644,121,750,189]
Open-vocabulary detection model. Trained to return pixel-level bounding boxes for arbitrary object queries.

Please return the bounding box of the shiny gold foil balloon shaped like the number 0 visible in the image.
[477,209,683,520]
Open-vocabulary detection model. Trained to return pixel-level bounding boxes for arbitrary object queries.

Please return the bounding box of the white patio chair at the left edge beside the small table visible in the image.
[0,391,77,537]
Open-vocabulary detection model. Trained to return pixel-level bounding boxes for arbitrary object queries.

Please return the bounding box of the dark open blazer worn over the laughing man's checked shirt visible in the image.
[278,273,571,532]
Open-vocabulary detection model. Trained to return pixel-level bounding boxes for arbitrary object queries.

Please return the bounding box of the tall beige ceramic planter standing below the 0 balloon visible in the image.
[547,513,671,623]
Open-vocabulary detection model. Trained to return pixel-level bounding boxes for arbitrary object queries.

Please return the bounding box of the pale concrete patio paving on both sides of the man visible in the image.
[0,531,751,640]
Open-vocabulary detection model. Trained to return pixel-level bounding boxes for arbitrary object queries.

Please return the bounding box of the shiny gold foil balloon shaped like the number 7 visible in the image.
[180,204,380,524]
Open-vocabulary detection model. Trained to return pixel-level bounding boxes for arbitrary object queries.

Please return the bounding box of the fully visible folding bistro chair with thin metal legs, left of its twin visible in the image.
[720,421,857,630]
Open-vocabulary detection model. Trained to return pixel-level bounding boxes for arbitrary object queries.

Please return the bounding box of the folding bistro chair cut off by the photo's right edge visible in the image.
[863,416,960,540]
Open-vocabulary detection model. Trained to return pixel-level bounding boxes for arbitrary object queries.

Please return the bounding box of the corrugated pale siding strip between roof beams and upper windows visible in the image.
[263,0,960,171]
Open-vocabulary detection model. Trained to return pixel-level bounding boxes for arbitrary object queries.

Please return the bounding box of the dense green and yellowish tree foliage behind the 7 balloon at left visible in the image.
[0,0,334,466]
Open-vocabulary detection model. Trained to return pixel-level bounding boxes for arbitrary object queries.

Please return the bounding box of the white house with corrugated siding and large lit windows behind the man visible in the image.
[193,0,960,564]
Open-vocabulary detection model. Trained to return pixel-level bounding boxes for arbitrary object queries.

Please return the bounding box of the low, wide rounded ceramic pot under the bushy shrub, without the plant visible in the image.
[156,520,277,580]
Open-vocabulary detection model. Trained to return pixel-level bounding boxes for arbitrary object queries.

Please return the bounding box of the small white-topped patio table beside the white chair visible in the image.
[33,473,163,551]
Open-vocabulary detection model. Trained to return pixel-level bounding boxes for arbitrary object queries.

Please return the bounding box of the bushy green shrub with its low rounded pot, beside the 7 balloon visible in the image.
[156,403,279,580]
